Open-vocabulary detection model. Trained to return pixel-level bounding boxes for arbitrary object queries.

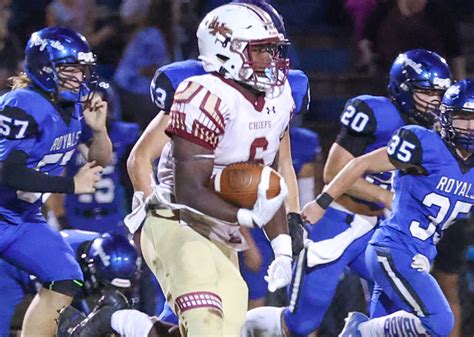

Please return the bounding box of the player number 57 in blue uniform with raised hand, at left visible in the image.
[0,27,112,336]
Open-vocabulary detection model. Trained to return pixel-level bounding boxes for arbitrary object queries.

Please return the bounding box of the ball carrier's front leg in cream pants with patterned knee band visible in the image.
[141,210,223,337]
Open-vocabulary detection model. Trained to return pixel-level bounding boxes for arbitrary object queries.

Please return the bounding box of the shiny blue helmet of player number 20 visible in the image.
[388,49,451,127]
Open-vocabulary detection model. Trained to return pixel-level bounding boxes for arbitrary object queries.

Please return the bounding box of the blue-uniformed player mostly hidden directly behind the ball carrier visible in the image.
[127,0,310,229]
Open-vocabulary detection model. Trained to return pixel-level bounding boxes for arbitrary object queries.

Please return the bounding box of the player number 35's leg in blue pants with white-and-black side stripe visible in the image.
[341,245,454,337]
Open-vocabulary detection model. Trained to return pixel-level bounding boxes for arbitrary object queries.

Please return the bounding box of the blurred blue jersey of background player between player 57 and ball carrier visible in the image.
[65,121,140,233]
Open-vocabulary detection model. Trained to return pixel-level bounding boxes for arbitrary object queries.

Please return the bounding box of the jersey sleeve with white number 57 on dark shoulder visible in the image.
[0,105,40,160]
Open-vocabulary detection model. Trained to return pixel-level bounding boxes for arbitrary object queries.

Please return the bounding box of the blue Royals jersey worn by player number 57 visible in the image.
[0,88,88,223]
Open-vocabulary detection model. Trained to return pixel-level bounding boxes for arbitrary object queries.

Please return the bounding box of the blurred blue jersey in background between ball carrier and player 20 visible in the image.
[290,128,321,175]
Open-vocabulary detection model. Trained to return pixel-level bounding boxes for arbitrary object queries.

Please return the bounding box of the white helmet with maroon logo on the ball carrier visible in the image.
[196,3,289,92]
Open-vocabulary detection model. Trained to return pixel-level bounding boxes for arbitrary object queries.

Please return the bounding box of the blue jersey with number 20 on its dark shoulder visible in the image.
[336,95,406,209]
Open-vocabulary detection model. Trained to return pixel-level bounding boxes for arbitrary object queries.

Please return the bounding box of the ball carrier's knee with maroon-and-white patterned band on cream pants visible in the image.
[175,291,224,337]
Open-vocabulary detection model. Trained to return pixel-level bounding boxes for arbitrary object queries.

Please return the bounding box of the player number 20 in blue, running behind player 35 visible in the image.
[245,49,451,336]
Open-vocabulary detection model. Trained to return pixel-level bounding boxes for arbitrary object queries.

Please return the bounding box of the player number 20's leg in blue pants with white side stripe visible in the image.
[241,208,371,337]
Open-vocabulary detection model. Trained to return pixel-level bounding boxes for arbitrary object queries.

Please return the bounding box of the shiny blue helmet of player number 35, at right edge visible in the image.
[440,79,474,152]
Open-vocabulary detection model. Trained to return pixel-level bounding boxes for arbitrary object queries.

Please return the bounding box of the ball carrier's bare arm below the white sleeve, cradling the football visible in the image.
[172,136,239,223]
